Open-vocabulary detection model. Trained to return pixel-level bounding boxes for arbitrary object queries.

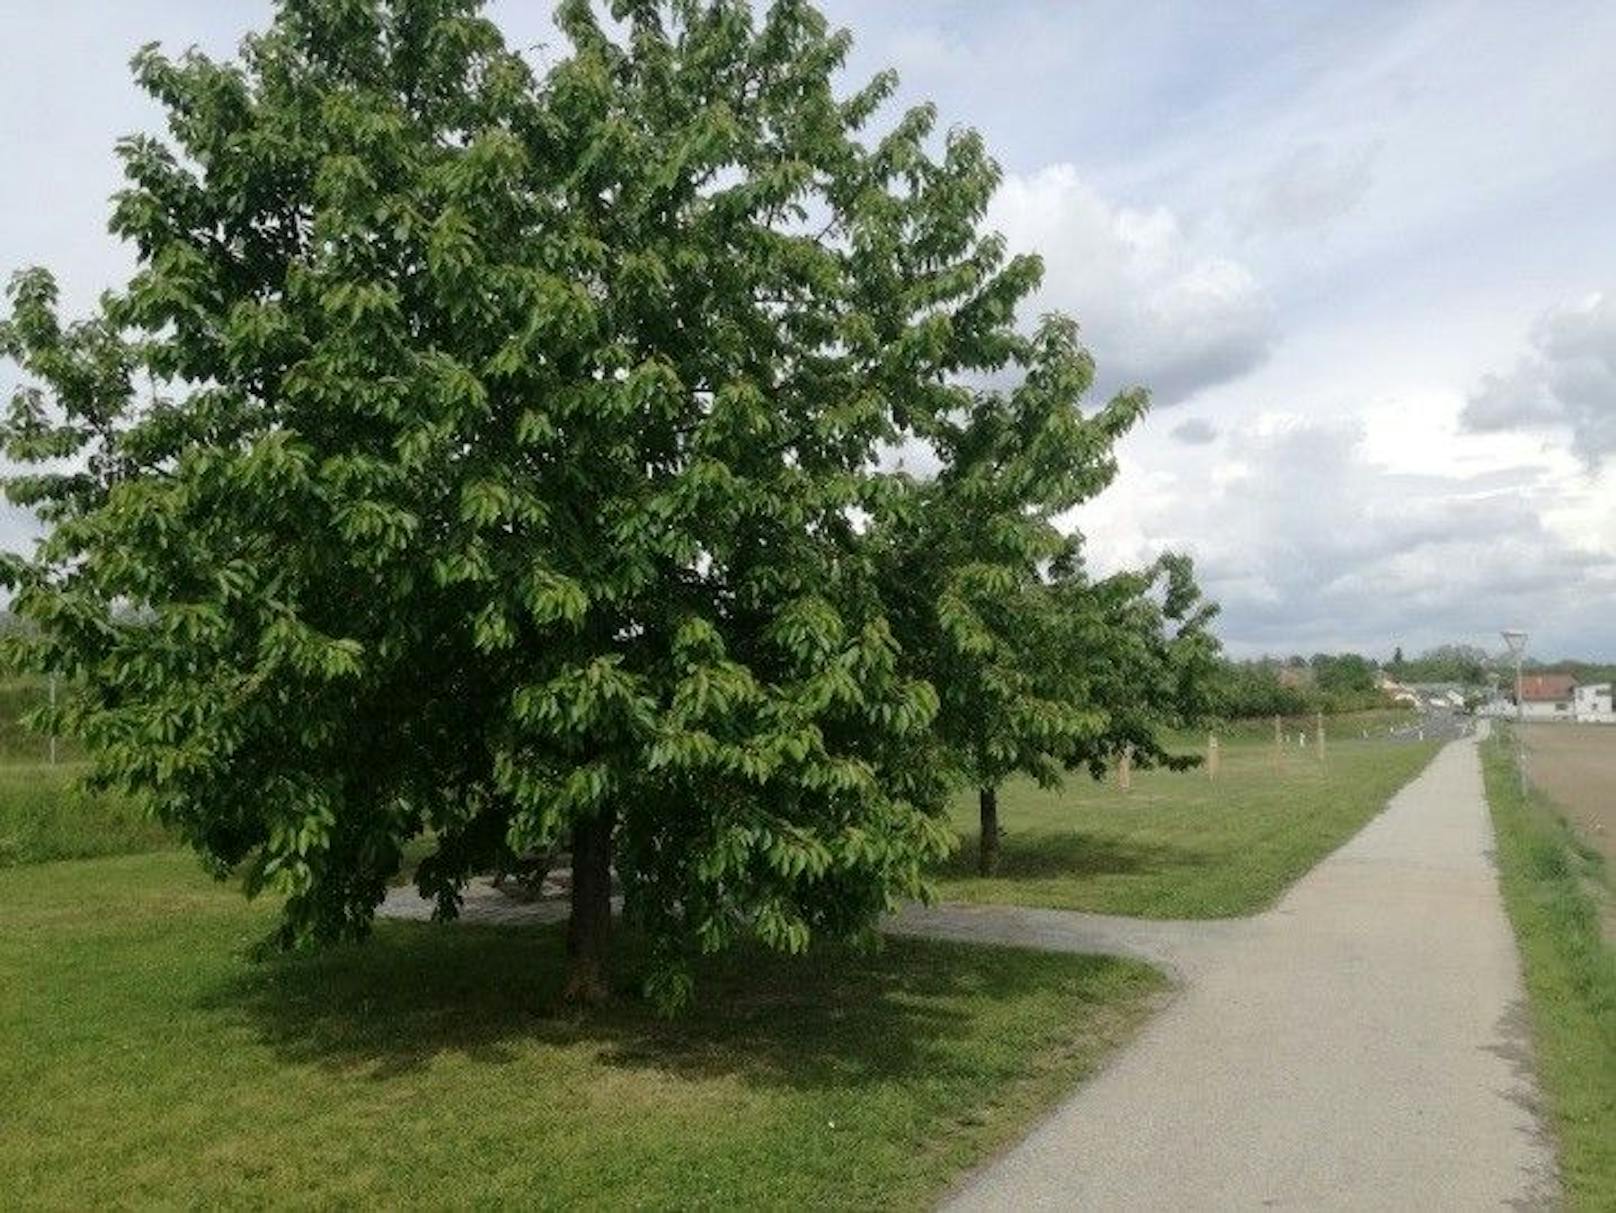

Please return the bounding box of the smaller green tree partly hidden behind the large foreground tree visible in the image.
[887,303,1215,874]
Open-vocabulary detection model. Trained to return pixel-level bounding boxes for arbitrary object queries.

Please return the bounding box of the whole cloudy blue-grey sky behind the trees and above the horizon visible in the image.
[0,0,1616,661]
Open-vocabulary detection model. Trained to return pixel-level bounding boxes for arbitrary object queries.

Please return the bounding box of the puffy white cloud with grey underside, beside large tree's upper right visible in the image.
[987,165,1273,405]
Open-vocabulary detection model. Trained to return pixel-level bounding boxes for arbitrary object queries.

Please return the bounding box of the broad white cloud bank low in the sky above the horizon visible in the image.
[1075,413,1616,665]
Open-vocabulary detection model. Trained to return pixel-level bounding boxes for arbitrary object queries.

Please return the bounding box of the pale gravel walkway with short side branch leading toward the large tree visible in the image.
[930,726,1556,1210]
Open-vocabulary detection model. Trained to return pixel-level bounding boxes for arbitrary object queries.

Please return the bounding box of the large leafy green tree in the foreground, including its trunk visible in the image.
[0,0,1215,1005]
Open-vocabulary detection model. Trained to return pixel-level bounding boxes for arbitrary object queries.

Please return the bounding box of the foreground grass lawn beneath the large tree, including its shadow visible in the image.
[0,851,1164,1208]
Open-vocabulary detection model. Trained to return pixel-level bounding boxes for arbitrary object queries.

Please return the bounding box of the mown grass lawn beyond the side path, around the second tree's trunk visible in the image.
[939,736,1438,917]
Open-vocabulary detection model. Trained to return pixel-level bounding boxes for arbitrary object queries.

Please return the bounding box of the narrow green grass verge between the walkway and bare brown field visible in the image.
[1482,730,1616,1210]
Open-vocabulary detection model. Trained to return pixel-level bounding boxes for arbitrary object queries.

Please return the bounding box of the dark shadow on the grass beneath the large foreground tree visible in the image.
[195,922,1118,1089]
